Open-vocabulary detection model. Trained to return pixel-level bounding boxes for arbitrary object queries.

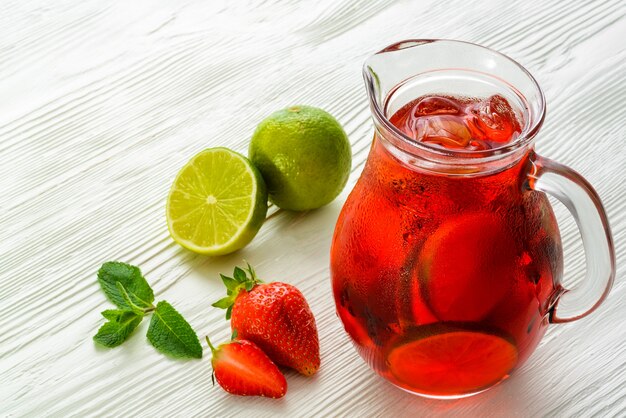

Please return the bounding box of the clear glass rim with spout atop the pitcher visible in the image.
[363,38,546,160]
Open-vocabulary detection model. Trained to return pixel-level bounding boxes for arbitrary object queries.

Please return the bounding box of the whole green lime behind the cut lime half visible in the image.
[248,106,352,211]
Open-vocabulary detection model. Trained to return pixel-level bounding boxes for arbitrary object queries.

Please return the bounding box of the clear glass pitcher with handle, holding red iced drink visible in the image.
[331,40,615,398]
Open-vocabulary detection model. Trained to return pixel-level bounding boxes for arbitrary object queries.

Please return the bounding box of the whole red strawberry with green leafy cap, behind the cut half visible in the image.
[213,264,320,376]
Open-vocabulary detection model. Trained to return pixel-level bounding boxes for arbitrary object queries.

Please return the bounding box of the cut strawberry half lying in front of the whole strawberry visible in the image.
[206,337,287,398]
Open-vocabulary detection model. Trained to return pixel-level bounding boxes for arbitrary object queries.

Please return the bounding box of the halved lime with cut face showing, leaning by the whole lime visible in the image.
[166,147,267,255]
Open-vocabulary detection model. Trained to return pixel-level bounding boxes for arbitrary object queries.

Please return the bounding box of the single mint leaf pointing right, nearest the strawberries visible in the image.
[146,300,202,358]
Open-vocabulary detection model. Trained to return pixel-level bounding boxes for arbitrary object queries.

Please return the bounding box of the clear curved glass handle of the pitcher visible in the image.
[528,156,615,324]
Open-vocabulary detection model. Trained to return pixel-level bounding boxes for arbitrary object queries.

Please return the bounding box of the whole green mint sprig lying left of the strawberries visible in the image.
[93,261,202,358]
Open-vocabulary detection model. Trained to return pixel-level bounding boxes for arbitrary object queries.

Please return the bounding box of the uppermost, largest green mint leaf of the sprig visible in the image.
[98,261,154,310]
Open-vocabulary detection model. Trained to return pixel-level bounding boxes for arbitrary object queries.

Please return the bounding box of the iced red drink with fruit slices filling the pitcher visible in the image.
[331,96,562,397]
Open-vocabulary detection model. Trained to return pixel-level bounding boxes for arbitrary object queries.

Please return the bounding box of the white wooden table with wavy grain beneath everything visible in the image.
[0,0,626,417]
